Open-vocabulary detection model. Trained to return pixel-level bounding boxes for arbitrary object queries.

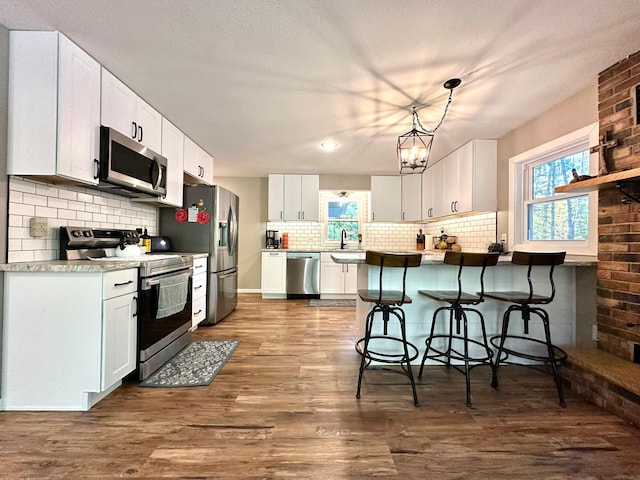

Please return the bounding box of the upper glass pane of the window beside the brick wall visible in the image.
[531,150,589,199]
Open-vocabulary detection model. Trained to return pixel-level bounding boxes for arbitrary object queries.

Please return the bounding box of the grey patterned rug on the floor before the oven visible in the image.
[140,340,240,387]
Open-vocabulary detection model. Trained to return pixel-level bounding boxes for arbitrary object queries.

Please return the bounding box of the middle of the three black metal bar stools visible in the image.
[418,251,500,407]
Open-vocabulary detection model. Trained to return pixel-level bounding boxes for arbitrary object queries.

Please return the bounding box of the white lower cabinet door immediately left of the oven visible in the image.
[101,293,137,390]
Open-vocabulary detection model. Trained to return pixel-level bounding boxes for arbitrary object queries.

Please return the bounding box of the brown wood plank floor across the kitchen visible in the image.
[0,295,640,480]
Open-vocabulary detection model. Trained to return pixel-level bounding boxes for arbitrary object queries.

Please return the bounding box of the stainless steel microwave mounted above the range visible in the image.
[98,126,167,197]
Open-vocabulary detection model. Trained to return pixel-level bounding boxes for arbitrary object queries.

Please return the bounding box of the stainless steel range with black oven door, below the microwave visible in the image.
[60,227,193,380]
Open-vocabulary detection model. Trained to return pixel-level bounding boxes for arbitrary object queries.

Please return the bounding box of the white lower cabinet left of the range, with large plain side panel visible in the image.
[2,268,138,410]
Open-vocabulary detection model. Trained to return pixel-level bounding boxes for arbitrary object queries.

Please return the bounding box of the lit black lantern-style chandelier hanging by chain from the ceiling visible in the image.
[397,78,462,175]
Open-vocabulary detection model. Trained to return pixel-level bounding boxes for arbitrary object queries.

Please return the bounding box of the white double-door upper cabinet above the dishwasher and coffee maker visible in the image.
[269,173,320,222]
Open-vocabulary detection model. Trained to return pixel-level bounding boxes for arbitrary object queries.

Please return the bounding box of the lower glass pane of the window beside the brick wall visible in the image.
[527,195,589,240]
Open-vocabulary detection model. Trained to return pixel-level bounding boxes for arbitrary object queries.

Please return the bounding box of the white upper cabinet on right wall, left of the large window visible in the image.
[424,140,497,218]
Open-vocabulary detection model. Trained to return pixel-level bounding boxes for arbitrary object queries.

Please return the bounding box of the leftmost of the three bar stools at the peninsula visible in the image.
[356,250,422,407]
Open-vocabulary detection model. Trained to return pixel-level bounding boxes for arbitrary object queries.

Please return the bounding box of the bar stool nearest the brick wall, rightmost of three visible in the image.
[485,252,567,407]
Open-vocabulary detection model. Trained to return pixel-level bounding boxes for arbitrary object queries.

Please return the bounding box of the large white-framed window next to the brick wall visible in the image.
[509,124,598,255]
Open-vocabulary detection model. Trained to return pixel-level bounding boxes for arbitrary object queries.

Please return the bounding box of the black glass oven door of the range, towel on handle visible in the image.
[138,270,193,363]
